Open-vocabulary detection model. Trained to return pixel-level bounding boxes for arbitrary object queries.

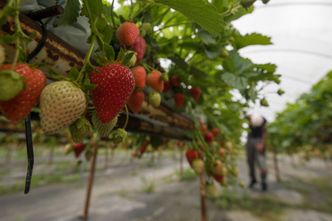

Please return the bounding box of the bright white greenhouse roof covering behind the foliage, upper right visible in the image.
[233,0,332,120]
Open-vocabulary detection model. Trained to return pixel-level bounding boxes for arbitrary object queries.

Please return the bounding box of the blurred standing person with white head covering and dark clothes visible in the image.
[246,114,267,191]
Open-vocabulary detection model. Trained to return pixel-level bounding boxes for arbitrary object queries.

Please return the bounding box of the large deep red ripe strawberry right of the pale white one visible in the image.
[90,64,135,123]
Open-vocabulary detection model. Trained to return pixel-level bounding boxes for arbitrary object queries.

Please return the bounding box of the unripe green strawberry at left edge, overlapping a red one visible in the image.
[0,70,25,101]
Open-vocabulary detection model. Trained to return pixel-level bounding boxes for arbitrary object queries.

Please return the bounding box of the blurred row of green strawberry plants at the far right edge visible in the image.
[269,72,332,158]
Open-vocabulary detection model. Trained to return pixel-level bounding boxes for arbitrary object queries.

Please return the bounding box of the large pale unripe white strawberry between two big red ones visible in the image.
[40,81,86,134]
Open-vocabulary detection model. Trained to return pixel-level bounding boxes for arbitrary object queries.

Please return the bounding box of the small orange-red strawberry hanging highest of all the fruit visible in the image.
[116,22,139,46]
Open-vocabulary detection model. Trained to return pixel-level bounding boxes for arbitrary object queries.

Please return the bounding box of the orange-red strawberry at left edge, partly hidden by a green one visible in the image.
[0,64,46,122]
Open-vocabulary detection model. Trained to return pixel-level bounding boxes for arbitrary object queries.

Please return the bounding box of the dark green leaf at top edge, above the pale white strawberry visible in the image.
[57,0,82,25]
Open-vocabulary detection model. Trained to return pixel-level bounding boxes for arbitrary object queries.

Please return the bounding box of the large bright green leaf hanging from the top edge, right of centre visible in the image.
[155,0,224,36]
